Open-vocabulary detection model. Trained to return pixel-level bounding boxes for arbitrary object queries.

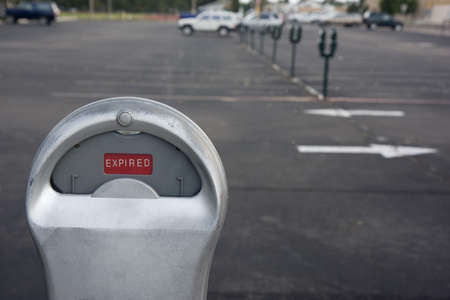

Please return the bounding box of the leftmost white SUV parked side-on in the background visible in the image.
[178,11,239,37]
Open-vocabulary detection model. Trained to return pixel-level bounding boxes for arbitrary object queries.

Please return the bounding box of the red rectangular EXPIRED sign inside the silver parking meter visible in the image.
[103,153,153,175]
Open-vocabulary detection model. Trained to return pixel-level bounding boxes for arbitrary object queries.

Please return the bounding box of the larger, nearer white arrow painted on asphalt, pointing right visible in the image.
[296,144,438,158]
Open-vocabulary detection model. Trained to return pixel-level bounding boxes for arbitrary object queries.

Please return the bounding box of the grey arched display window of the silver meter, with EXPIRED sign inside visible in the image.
[51,131,202,197]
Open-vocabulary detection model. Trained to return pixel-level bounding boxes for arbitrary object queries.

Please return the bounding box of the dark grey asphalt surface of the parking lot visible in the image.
[0,21,450,299]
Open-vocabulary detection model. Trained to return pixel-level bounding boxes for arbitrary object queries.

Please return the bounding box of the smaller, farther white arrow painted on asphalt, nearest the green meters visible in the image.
[304,108,405,118]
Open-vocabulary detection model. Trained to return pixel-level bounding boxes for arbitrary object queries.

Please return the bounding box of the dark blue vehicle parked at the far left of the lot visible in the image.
[5,2,60,25]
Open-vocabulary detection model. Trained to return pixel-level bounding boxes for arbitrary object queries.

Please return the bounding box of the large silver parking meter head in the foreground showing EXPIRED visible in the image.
[26,98,228,299]
